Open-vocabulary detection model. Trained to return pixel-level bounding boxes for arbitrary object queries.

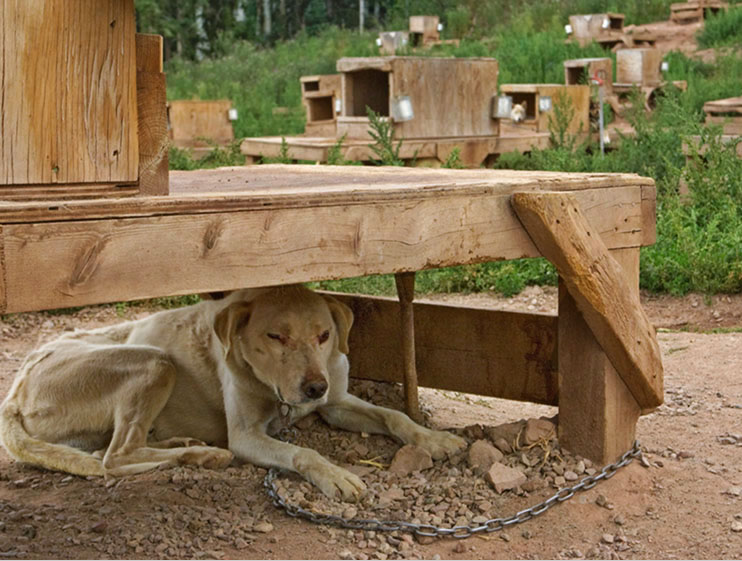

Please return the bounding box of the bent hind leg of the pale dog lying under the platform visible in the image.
[103,349,233,475]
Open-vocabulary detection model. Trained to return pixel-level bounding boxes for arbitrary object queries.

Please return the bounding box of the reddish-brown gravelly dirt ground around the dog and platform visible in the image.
[0,287,742,559]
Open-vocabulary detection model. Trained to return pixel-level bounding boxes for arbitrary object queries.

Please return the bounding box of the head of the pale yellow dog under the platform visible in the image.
[214,286,353,405]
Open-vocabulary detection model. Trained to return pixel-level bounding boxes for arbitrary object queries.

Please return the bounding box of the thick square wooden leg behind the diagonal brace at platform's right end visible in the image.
[557,248,641,464]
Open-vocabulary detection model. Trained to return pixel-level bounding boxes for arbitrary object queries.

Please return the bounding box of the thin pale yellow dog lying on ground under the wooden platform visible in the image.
[0,285,465,500]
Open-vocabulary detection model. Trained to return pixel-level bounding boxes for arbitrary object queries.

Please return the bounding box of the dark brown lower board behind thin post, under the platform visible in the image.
[332,293,558,405]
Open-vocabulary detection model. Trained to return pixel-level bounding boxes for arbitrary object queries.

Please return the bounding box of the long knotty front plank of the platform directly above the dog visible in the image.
[0,187,643,312]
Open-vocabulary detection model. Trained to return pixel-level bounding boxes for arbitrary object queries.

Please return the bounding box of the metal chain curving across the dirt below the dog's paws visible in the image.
[263,440,642,538]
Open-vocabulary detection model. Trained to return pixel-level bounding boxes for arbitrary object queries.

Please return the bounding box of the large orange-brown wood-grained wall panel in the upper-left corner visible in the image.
[0,0,139,186]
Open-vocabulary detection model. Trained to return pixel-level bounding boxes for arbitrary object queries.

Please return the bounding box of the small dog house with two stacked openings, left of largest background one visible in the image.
[300,74,342,136]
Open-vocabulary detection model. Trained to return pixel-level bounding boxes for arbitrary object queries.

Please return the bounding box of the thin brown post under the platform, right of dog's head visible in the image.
[394,272,422,422]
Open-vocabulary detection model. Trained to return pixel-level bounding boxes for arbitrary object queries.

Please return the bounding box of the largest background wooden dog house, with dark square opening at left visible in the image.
[337,57,498,139]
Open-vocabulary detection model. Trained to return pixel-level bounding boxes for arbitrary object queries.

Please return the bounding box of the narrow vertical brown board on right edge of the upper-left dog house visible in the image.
[136,33,170,195]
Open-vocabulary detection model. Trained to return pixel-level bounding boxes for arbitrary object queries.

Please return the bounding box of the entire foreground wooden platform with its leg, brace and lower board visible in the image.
[0,166,662,461]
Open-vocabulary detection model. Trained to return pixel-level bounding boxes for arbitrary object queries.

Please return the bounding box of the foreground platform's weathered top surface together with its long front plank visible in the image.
[0,166,652,312]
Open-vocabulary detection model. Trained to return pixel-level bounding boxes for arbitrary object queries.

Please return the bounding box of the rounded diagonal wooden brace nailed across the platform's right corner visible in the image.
[512,192,663,409]
